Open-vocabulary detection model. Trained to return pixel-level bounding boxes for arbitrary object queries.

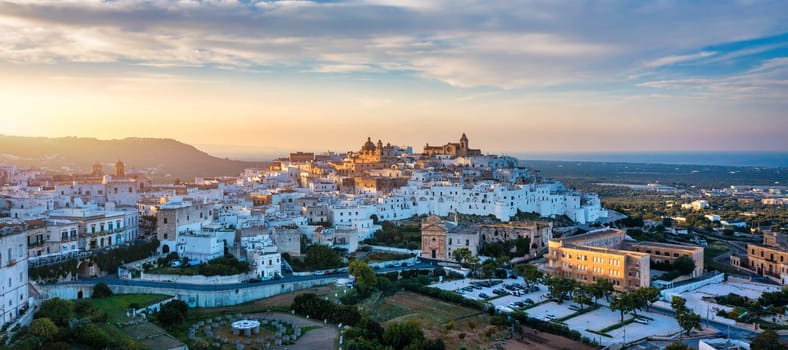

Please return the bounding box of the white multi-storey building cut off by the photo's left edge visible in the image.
[0,225,28,324]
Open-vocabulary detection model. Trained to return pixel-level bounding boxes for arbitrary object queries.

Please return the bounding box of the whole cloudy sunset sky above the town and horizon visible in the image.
[0,0,788,153]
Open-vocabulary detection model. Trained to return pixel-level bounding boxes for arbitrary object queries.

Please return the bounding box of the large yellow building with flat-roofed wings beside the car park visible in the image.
[546,229,703,291]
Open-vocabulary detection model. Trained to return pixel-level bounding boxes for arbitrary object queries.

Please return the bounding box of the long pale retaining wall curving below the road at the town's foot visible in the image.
[42,276,338,307]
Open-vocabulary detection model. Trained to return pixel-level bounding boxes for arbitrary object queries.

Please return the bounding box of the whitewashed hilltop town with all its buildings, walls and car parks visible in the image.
[0,134,788,349]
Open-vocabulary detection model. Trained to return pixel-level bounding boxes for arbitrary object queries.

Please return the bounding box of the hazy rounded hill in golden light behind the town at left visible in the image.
[0,135,263,181]
